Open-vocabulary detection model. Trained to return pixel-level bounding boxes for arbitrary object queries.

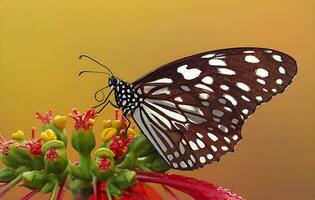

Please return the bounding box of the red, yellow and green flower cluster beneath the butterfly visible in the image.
[0,109,242,200]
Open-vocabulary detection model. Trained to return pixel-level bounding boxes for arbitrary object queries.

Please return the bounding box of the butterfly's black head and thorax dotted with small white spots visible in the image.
[109,76,141,116]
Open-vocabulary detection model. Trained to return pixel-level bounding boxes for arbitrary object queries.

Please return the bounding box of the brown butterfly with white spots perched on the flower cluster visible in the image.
[81,47,297,170]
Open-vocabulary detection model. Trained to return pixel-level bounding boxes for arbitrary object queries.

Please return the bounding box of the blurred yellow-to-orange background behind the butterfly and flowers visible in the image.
[0,0,315,200]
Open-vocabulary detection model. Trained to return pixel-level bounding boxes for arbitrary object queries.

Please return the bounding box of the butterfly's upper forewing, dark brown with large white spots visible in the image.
[133,47,297,119]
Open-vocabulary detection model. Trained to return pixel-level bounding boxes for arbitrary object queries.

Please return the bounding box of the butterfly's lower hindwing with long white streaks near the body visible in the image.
[133,85,243,170]
